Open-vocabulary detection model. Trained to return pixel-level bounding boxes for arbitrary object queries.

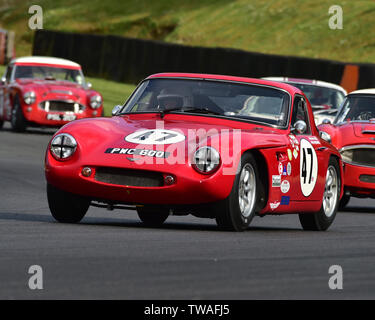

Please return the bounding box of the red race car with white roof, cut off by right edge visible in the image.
[319,89,375,208]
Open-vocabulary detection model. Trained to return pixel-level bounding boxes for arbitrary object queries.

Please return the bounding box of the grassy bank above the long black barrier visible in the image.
[0,0,375,63]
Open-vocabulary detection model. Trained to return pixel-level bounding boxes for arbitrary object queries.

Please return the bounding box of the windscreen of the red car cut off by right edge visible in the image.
[334,95,375,124]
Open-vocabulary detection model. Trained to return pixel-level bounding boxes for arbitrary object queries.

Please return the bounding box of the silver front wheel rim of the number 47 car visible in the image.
[238,163,256,218]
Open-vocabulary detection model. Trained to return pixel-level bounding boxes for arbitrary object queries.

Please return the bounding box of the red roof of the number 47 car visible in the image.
[147,72,302,94]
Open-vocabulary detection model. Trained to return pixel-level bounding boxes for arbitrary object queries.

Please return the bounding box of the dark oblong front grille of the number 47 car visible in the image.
[95,167,164,187]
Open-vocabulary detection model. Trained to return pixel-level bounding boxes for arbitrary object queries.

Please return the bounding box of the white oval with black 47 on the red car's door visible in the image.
[299,139,318,197]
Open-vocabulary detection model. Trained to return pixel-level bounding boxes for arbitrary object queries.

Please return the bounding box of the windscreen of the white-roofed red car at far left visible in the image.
[14,65,84,85]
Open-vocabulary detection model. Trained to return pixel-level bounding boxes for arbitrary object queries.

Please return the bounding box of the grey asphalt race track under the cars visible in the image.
[0,126,375,299]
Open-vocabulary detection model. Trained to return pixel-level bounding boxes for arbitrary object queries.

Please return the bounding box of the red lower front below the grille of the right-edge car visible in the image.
[344,163,375,197]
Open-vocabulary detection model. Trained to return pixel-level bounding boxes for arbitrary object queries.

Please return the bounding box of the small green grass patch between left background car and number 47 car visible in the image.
[0,66,135,116]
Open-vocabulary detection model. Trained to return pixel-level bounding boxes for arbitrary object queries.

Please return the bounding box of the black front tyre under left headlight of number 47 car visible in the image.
[47,184,90,223]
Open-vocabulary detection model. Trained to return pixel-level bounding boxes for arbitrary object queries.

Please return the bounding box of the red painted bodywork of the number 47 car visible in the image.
[45,73,342,214]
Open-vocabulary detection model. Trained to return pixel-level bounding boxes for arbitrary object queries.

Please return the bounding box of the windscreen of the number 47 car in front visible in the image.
[121,79,290,127]
